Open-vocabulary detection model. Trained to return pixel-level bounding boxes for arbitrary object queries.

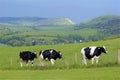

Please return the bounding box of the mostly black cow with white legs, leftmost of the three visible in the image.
[19,51,37,67]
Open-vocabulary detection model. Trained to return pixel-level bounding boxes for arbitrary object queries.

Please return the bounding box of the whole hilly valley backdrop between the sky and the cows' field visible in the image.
[0,15,120,46]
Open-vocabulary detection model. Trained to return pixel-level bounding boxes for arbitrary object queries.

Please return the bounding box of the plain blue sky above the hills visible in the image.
[0,0,120,23]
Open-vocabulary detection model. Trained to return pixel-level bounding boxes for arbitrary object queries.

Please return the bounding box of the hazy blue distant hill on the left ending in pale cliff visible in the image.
[0,17,74,26]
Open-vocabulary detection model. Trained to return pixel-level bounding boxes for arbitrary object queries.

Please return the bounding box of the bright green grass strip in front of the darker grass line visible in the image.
[0,67,120,80]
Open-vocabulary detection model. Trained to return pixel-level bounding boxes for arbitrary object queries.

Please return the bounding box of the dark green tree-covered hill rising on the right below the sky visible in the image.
[75,15,120,35]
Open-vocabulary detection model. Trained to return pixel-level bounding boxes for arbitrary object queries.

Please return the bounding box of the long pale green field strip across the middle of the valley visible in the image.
[18,29,97,36]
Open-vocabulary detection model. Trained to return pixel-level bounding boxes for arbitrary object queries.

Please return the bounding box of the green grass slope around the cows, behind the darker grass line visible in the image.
[0,38,120,69]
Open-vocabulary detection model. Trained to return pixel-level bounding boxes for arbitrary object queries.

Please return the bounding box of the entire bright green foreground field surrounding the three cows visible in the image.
[0,38,120,80]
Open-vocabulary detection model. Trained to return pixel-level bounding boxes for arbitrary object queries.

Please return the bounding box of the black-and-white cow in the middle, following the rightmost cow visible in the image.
[39,49,62,66]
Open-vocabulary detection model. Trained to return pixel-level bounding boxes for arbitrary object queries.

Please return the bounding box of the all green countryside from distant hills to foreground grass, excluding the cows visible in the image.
[0,15,120,80]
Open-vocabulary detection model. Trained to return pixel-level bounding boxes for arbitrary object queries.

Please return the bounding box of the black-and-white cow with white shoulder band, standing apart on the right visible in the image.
[81,46,107,64]
